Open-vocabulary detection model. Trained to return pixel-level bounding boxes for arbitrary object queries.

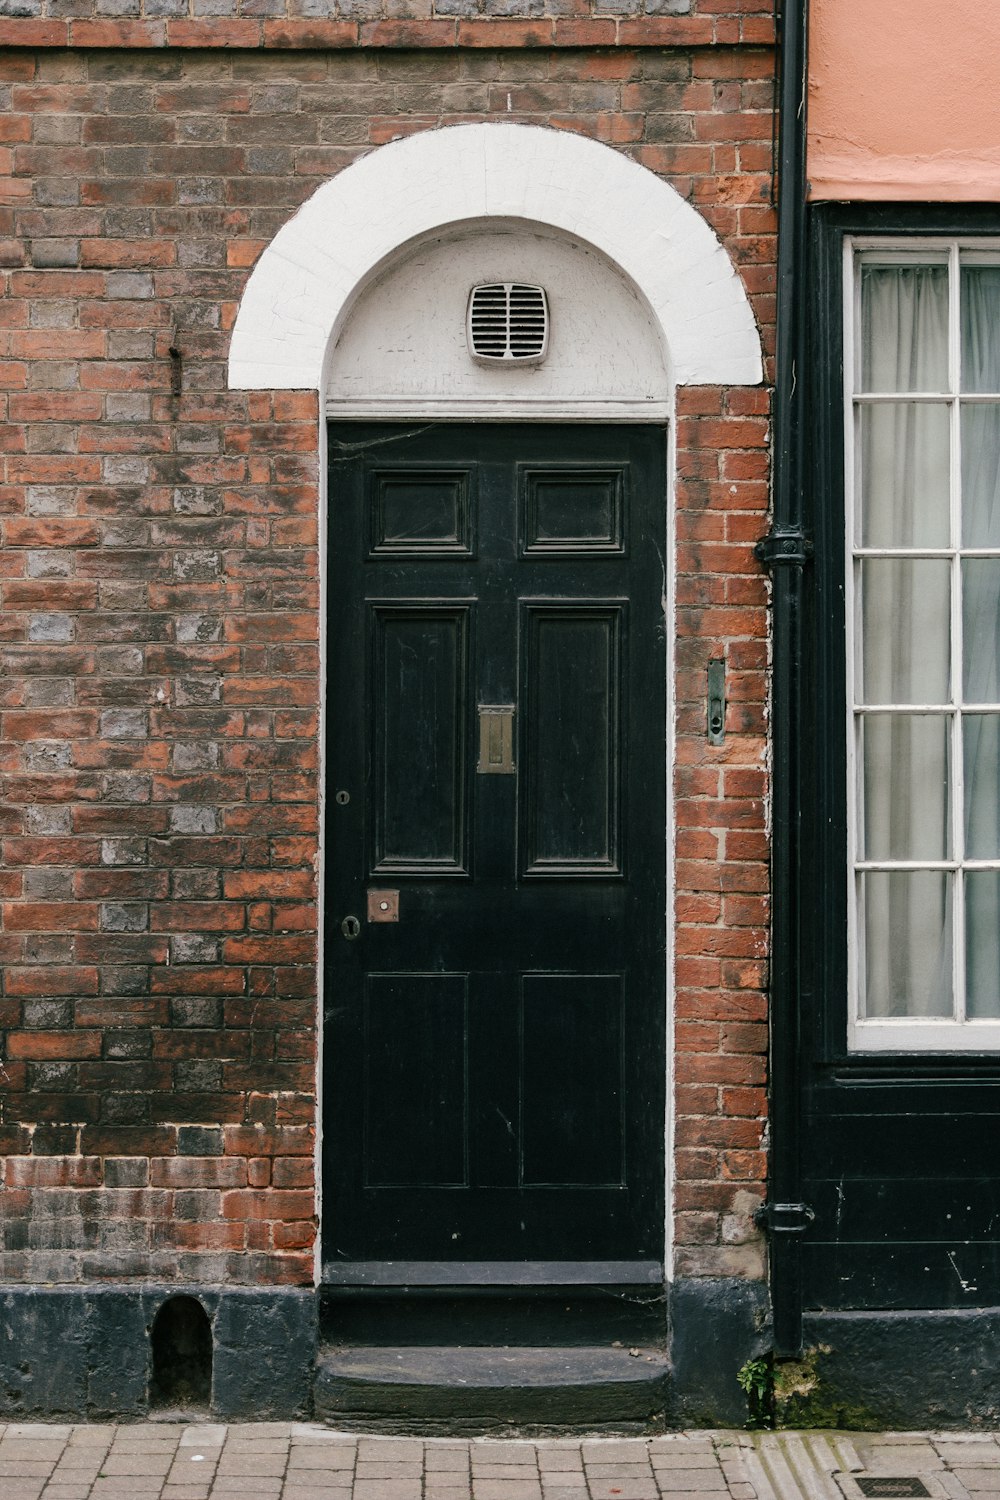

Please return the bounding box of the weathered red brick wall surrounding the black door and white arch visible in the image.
[0,35,774,1283]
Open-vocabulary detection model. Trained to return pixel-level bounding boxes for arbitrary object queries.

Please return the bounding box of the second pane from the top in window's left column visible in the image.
[861,401,951,548]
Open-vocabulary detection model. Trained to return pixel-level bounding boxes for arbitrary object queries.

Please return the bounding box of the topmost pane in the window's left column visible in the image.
[861,266,948,392]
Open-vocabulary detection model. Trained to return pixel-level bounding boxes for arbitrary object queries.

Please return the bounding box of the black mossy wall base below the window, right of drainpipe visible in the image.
[775,1308,1000,1431]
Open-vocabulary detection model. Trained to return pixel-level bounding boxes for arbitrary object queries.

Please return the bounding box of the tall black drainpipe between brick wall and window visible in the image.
[754,0,813,1356]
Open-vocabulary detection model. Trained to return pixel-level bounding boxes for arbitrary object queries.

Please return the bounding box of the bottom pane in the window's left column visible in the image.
[859,870,952,1017]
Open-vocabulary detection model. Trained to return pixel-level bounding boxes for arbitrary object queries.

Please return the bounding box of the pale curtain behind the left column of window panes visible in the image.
[856,266,954,1016]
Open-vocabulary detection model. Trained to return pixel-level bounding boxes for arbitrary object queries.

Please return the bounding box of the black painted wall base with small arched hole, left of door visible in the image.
[0,1284,316,1421]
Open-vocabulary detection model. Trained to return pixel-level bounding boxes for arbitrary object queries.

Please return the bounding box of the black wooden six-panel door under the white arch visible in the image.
[324,425,666,1280]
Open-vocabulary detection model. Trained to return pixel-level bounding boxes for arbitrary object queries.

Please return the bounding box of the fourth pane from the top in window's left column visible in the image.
[858,714,951,860]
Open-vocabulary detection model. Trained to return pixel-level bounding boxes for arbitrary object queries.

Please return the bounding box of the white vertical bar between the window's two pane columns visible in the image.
[948,240,966,1025]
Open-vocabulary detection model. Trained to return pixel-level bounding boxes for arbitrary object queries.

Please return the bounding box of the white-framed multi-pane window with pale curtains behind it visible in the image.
[846,240,1000,1049]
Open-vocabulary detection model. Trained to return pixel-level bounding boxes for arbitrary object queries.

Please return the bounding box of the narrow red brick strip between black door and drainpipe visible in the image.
[675,384,771,1277]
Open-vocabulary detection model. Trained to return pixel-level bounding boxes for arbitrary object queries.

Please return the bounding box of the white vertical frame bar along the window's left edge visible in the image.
[843,236,864,1047]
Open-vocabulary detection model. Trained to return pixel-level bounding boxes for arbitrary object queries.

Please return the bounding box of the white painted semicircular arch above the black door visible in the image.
[229,125,763,390]
